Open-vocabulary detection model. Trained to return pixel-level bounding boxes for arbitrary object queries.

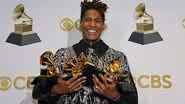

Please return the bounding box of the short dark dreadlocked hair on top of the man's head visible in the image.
[80,0,108,22]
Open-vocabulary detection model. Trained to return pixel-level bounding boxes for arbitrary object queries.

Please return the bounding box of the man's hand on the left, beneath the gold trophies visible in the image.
[51,74,86,95]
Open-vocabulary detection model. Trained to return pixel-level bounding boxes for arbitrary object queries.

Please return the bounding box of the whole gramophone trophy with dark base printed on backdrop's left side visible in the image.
[6,4,41,46]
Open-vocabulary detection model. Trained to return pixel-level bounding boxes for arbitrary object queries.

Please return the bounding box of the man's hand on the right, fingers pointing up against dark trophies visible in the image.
[93,74,120,101]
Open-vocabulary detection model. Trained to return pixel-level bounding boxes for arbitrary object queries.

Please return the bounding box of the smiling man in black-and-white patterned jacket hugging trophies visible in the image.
[33,0,138,104]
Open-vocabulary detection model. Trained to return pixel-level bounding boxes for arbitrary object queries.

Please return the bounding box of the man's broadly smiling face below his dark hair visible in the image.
[80,9,104,41]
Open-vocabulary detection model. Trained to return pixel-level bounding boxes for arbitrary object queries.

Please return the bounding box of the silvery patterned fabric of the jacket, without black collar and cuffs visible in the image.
[52,41,136,104]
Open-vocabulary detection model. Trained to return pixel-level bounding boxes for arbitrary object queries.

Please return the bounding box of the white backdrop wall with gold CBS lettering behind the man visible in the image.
[0,0,185,104]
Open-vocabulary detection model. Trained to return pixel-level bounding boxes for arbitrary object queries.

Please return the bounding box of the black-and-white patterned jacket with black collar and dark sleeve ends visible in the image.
[33,40,138,104]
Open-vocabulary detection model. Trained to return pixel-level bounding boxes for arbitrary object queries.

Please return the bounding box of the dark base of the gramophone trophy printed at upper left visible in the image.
[6,32,41,46]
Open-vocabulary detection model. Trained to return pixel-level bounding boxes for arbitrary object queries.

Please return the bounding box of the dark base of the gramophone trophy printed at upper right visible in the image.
[128,32,163,45]
